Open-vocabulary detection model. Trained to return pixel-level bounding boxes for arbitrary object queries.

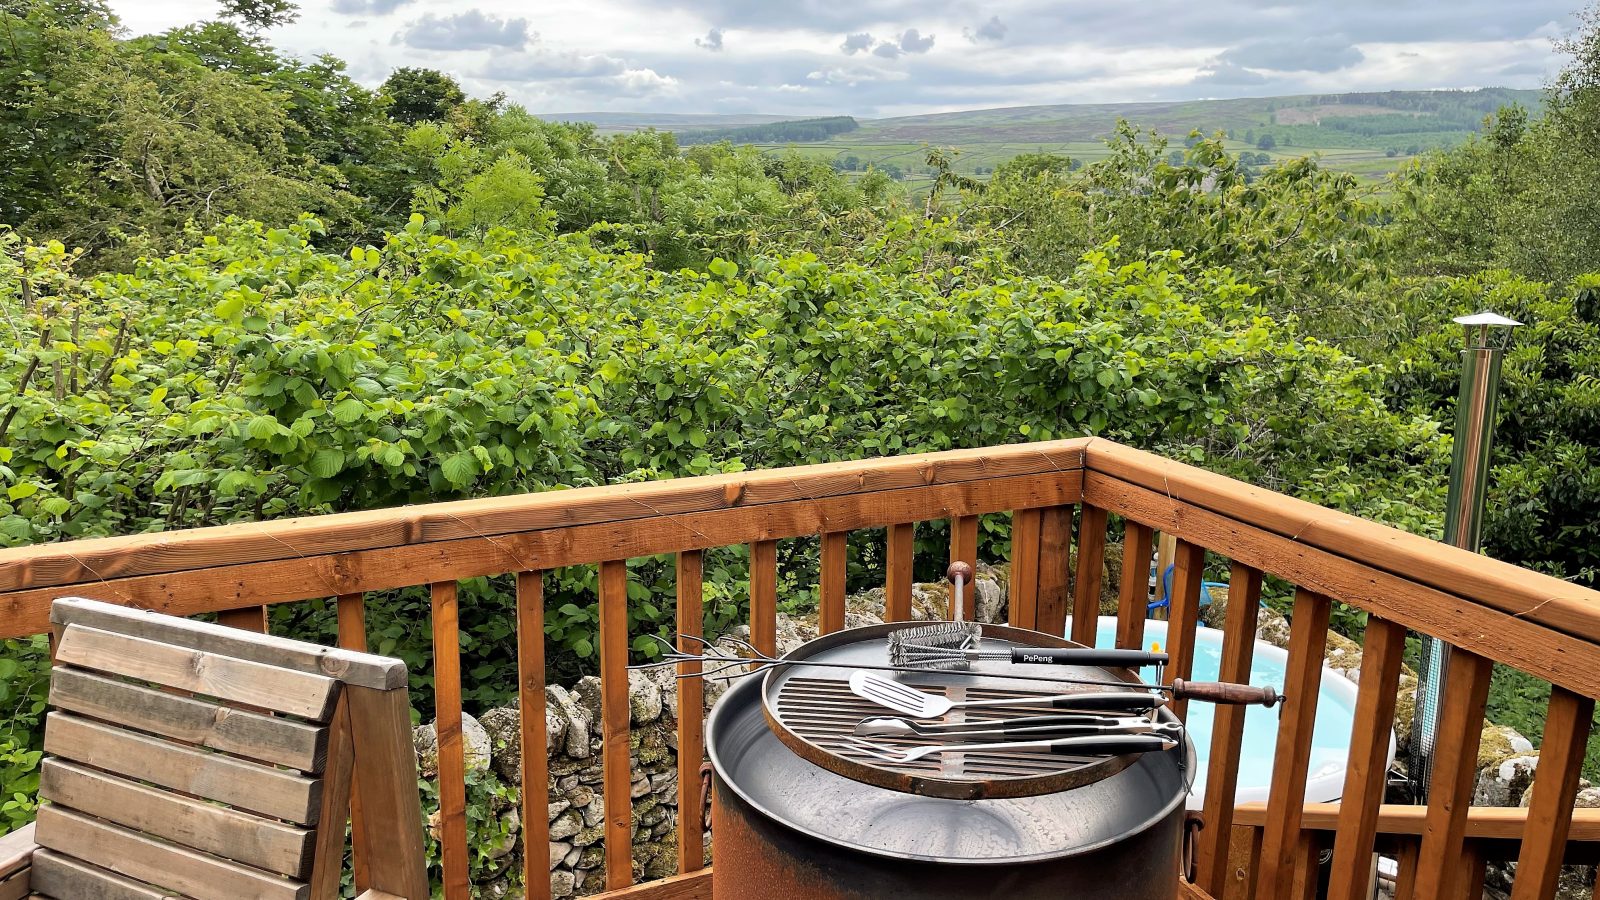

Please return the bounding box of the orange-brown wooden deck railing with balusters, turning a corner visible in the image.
[0,439,1600,900]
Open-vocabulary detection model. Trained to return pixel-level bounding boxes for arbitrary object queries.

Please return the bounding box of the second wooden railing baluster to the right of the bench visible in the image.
[517,572,550,900]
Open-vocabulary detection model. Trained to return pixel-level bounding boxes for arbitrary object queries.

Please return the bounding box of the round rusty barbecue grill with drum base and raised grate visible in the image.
[706,625,1195,900]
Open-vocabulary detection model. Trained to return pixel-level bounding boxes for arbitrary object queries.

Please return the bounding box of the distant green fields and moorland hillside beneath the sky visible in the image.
[552,88,1541,183]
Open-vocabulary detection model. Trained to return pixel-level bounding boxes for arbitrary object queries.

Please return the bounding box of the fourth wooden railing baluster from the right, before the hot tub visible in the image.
[1254,586,1333,900]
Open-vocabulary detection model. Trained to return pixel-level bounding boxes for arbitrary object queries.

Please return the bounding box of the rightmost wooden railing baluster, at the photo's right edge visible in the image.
[1510,687,1595,900]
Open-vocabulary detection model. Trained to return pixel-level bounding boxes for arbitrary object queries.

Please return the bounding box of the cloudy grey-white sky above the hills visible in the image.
[110,0,1582,117]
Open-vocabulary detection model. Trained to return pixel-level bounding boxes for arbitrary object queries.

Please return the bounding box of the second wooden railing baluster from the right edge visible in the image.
[1400,649,1493,900]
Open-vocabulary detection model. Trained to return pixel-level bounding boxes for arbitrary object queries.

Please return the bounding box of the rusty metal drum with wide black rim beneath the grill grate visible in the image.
[706,626,1195,900]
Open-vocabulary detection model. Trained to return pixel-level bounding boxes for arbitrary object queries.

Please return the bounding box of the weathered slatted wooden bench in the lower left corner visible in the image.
[0,599,429,900]
